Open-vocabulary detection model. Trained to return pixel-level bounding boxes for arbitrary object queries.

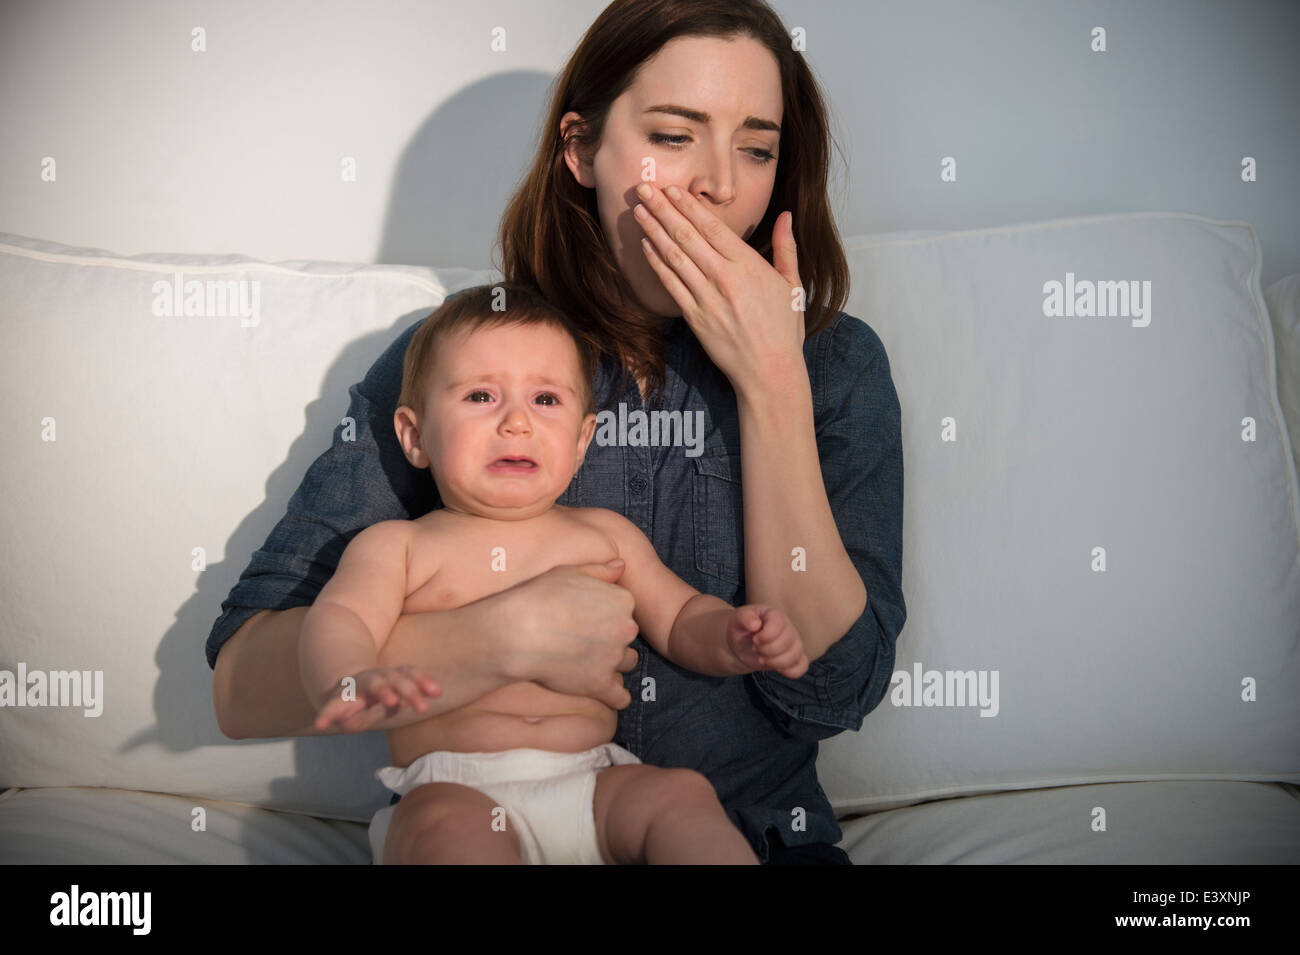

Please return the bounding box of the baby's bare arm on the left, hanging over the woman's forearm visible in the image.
[298,521,441,730]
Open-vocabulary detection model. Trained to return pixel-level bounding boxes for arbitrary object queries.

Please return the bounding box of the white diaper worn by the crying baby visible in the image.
[371,743,641,865]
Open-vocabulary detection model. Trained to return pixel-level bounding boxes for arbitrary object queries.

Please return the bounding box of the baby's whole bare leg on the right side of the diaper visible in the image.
[594,765,758,865]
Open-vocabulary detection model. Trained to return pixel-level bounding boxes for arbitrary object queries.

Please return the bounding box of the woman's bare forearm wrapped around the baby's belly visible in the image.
[212,602,514,739]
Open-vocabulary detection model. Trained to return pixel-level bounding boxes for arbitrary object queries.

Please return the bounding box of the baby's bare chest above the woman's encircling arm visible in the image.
[402,517,619,613]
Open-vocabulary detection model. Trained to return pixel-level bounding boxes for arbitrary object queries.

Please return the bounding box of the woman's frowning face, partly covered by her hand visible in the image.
[562,36,781,317]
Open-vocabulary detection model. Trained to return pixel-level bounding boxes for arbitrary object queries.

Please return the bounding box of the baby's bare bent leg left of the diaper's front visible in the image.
[384,782,521,865]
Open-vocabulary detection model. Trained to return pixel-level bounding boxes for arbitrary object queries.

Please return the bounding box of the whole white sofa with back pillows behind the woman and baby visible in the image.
[0,213,1300,864]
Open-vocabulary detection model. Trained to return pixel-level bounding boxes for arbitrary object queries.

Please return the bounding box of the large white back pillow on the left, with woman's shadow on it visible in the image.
[0,234,497,820]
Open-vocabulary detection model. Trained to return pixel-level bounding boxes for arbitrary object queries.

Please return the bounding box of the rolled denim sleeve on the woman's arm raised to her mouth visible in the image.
[749,313,907,742]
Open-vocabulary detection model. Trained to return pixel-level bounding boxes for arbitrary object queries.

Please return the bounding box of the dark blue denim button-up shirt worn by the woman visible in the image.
[207,294,906,861]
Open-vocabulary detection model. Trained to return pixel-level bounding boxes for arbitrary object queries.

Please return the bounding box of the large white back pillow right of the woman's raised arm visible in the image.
[819,213,1300,811]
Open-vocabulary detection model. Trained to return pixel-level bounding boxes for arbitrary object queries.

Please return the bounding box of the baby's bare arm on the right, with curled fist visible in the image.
[588,508,809,680]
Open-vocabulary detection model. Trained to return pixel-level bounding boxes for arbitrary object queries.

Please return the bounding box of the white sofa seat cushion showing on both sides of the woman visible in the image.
[0,781,1300,865]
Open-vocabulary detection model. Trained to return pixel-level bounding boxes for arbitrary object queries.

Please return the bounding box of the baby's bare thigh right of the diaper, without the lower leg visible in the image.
[593,764,727,865]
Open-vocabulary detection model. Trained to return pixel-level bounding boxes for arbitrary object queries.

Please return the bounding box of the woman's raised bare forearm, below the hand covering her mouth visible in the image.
[736,363,867,660]
